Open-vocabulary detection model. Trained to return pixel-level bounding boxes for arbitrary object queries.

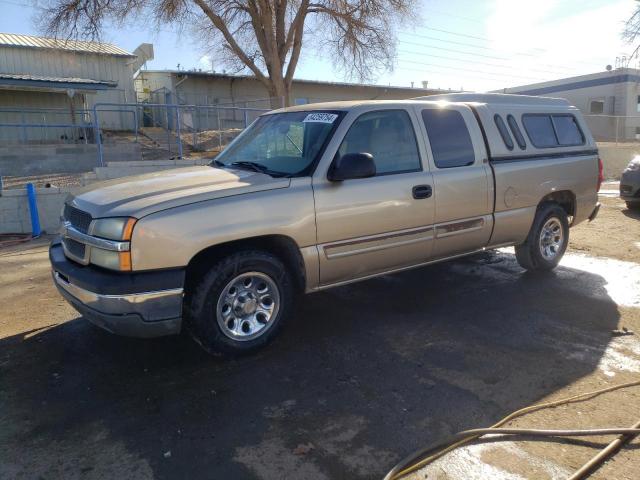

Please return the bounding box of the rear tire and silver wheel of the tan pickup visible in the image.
[516,203,569,271]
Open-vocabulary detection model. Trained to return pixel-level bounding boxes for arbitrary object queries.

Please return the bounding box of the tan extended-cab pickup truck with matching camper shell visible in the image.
[50,94,602,353]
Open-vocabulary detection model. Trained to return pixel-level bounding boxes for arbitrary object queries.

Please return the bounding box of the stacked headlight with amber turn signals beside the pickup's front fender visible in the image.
[89,217,137,272]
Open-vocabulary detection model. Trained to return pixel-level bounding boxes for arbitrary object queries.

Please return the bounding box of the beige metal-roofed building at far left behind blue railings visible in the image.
[0,33,146,143]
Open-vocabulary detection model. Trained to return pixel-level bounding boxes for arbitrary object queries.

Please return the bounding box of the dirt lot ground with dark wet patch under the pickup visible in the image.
[0,198,640,480]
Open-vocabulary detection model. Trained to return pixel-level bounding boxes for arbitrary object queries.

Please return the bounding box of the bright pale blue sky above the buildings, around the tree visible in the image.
[0,0,640,91]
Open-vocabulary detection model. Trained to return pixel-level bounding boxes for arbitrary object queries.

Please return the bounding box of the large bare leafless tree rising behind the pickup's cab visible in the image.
[42,0,415,104]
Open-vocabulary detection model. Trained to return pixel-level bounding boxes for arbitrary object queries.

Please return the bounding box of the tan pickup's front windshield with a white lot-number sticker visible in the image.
[214,111,341,176]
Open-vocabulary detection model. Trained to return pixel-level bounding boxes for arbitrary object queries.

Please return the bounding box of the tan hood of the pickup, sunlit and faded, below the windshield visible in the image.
[67,166,290,218]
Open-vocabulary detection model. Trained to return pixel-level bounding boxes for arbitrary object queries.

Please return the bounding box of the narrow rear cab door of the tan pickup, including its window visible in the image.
[416,104,493,258]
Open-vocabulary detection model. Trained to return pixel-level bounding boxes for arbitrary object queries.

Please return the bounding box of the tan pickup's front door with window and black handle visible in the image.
[313,107,434,285]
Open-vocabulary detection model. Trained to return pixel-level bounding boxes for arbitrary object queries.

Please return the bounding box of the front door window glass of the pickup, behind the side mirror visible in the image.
[338,110,422,175]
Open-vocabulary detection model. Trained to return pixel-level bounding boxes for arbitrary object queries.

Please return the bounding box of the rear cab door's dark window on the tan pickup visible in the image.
[422,108,476,168]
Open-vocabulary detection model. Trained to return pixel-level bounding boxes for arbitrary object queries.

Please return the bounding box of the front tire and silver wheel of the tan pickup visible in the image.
[185,250,295,355]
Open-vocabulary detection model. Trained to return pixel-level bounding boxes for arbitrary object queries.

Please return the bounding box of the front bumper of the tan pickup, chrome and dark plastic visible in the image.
[49,237,184,338]
